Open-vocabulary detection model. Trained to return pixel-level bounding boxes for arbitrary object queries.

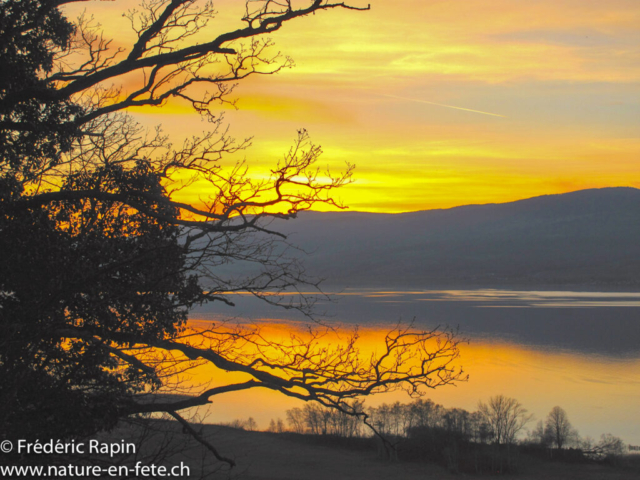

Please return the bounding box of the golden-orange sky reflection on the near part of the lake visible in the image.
[180,320,640,444]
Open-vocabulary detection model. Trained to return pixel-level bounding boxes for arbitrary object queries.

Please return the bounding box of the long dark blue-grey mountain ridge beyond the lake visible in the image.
[271,188,640,287]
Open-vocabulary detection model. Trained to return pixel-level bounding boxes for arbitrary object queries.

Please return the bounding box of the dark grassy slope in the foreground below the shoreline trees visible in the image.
[101,422,640,480]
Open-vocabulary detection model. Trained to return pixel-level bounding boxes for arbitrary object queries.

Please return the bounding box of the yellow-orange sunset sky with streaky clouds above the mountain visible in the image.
[67,0,640,212]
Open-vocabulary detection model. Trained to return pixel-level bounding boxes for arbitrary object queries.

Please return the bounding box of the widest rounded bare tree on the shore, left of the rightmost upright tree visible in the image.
[478,395,533,444]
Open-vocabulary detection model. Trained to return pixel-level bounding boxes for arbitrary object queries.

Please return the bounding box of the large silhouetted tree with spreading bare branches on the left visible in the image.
[0,0,464,464]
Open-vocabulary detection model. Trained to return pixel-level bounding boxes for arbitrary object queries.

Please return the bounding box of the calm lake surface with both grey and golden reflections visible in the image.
[192,289,640,445]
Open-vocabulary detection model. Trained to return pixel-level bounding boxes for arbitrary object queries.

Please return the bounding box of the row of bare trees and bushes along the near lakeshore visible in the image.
[268,395,627,473]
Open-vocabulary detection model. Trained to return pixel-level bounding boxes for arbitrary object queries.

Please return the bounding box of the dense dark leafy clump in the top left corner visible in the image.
[0,0,83,179]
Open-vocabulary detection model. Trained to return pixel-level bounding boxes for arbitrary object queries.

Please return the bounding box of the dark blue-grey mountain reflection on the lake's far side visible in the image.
[194,289,640,358]
